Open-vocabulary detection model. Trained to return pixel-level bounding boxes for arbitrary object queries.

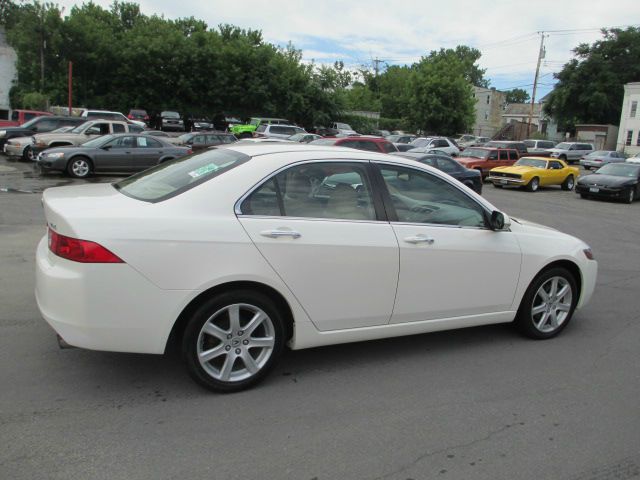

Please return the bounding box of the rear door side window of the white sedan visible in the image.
[241,163,376,220]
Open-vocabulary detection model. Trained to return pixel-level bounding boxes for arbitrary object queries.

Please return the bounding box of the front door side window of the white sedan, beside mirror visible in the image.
[380,165,485,227]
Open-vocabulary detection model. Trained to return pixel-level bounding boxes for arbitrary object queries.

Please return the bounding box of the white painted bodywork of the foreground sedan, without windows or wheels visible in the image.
[36,143,597,353]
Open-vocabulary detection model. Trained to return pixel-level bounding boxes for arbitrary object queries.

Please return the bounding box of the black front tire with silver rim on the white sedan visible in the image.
[514,267,579,340]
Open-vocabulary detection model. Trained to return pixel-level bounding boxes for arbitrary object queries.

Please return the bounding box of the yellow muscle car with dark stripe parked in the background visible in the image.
[487,157,580,192]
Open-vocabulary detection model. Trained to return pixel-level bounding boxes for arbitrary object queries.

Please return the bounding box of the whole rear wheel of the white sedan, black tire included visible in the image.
[182,290,286,392]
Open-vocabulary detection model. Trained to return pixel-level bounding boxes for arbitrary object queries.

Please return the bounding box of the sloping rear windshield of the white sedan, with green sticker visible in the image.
[114,149,251,203]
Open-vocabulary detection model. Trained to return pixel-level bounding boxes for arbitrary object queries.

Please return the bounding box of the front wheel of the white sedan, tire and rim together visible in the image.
[515,267,578,339]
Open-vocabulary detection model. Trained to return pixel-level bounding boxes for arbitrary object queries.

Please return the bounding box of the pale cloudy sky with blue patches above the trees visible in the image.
[55,0,640,99]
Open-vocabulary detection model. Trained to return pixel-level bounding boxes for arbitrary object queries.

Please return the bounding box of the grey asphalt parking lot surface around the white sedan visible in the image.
[0,156,640,480]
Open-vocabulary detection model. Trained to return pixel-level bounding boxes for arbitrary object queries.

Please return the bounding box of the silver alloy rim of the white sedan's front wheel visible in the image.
[531,277,573,333]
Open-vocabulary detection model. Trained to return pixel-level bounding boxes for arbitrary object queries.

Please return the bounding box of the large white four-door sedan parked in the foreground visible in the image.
[36,143,597,391]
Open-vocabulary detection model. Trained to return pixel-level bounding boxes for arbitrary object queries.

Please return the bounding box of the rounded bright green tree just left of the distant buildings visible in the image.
[409,52,475,135]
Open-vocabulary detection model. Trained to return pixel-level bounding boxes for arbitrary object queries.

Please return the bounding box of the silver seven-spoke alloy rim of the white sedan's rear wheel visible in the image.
[196,303,275,382]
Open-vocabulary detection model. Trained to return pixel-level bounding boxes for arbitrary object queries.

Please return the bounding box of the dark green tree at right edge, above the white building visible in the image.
[544,27,640,130]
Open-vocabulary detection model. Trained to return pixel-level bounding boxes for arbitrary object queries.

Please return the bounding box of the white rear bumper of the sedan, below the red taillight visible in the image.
[35,237,195,353]
